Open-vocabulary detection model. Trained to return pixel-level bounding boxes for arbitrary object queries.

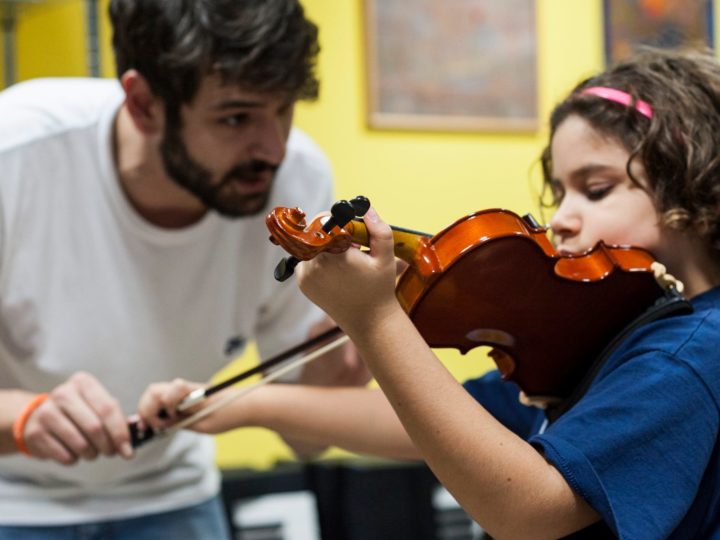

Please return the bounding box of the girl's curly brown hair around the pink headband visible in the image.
[541,49,720,258]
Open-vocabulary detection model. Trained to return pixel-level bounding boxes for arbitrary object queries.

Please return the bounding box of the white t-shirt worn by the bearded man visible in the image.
[0,79,332,524]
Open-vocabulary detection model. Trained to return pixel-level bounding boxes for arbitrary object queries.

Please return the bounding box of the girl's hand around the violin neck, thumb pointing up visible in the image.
[297,208,402,330]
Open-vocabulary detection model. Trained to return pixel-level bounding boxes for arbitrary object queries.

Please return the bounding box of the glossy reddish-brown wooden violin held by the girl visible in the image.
[266,198,682,401]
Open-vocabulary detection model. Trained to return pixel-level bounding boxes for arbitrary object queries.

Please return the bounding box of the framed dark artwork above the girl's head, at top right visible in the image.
[604,0,714,64]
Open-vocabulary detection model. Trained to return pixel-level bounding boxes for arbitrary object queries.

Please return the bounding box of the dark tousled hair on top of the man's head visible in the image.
[110,0,319,110]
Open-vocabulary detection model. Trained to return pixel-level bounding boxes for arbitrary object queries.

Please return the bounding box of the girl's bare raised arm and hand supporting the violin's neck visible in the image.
[298,209,598,538]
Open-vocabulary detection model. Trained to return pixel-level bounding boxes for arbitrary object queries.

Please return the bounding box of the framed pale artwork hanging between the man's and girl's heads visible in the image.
[364,0,538,131]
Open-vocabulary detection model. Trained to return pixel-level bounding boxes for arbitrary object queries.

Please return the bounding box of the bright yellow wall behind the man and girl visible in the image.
[0,0,704,467]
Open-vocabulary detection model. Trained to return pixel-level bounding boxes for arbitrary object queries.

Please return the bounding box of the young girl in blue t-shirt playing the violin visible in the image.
[139,51,720,539]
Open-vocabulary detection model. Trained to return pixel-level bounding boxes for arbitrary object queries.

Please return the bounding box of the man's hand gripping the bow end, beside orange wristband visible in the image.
[23,372,132,465]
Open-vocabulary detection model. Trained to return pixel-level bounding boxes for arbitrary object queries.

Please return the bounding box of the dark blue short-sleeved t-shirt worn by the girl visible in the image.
[465,288,720,540]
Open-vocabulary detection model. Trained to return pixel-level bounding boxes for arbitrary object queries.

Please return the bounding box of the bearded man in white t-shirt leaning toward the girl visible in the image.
[0,0,366,539]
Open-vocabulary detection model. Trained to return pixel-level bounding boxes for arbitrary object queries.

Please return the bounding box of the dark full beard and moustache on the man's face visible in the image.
[160,126,278,218]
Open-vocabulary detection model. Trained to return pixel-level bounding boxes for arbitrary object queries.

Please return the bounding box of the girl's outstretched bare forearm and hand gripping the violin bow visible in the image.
[138,379,420,459]
